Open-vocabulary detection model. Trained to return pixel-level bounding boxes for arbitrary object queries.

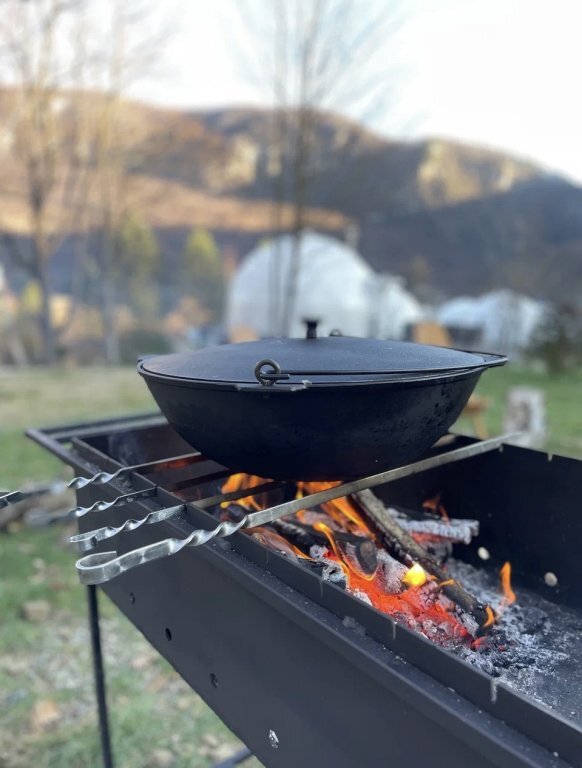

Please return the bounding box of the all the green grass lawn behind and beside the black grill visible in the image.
[0,366,582,768]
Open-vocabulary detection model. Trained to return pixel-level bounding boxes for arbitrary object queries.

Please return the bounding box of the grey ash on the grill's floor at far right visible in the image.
[447,558,582,725]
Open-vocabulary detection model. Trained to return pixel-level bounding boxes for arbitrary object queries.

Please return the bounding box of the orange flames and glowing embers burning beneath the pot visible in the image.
[221,474,488,644]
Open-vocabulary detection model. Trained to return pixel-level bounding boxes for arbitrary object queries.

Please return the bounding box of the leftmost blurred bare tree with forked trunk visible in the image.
[0,0,97,363]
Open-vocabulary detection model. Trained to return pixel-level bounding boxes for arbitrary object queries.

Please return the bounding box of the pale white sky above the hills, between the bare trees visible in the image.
[133,0,582,184]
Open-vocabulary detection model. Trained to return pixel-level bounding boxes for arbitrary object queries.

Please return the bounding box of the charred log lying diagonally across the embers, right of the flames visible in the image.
[353,490,494,637]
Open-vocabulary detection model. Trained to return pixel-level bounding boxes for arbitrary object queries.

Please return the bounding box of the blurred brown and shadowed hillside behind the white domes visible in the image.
[0,91,582,302]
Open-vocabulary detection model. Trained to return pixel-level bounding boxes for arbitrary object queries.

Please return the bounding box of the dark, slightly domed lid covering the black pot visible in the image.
[139,336,506,385]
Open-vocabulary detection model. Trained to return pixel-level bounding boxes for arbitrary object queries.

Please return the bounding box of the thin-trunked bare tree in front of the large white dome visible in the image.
[235,0,402,335]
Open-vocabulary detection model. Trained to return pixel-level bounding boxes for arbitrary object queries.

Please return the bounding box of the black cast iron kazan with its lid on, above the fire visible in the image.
[138,333,506,480]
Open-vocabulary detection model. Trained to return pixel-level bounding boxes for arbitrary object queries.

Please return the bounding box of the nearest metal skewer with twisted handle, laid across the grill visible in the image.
[76,434,515,584]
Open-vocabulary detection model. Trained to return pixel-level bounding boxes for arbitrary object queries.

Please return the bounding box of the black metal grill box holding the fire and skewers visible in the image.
[30,416,582,768]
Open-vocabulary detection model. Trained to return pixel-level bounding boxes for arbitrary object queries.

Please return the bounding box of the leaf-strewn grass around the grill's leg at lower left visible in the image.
[0,527,259,768]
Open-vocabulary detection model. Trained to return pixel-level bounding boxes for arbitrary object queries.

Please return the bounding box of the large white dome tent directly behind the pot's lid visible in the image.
[227,232,422,338]
